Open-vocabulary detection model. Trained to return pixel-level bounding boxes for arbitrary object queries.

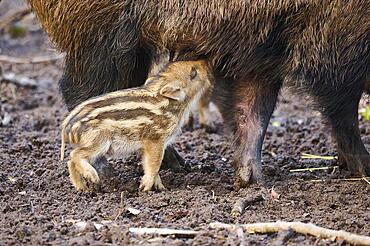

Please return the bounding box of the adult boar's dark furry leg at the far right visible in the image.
[313,83,370,176]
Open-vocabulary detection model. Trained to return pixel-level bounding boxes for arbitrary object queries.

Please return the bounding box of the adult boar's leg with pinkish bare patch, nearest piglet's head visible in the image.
[228,78,281,189]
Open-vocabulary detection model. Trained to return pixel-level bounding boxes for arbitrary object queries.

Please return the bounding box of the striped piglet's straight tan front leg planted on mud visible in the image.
[140,141,166,191]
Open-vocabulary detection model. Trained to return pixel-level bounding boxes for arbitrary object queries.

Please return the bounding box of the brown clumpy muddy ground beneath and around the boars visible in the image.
[0,1,370,245]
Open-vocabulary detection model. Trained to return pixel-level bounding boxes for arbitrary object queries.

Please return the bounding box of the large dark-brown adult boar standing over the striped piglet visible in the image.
[29,0,370,186]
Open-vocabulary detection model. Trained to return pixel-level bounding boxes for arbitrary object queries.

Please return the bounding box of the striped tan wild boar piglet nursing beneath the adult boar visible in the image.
[61,60,213,191]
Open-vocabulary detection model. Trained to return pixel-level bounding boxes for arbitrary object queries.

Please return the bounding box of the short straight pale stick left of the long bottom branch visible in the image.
[128,227,200,237]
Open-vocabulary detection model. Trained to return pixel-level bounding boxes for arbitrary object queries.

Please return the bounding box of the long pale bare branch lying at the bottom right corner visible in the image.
[210,221,370,245]
